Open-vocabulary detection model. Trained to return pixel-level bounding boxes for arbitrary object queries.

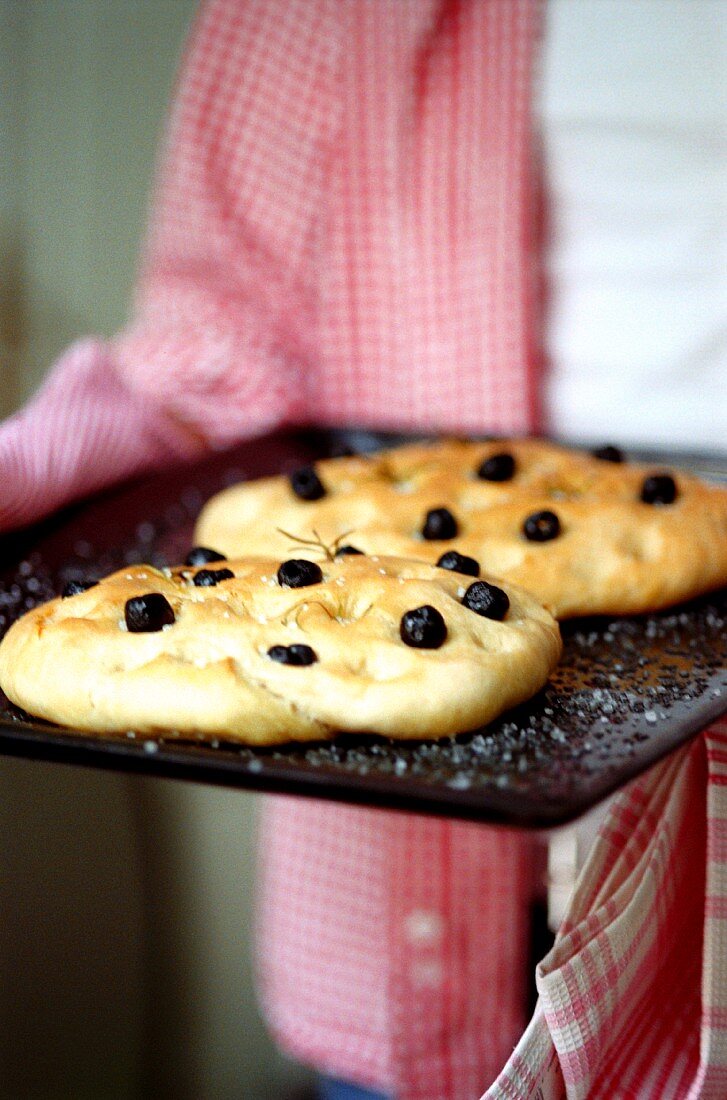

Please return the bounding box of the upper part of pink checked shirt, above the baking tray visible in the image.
[114,0,535,446]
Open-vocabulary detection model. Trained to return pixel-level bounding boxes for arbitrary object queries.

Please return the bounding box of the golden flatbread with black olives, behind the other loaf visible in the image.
[196,440,727,618]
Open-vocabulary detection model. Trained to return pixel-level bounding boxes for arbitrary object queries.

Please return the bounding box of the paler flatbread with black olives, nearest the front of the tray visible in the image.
[0,552,561,745]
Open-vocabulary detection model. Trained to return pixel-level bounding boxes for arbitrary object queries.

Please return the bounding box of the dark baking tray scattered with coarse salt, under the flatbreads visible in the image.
[0,432,727,827]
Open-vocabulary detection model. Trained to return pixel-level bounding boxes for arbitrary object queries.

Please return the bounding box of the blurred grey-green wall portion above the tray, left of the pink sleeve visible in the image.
[0,0,197,411]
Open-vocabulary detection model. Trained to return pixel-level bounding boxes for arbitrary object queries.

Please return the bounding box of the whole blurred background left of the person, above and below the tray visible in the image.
[0,0,307,1100]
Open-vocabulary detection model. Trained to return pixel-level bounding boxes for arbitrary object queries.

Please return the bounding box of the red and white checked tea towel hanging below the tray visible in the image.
[483,718,727,1100]
